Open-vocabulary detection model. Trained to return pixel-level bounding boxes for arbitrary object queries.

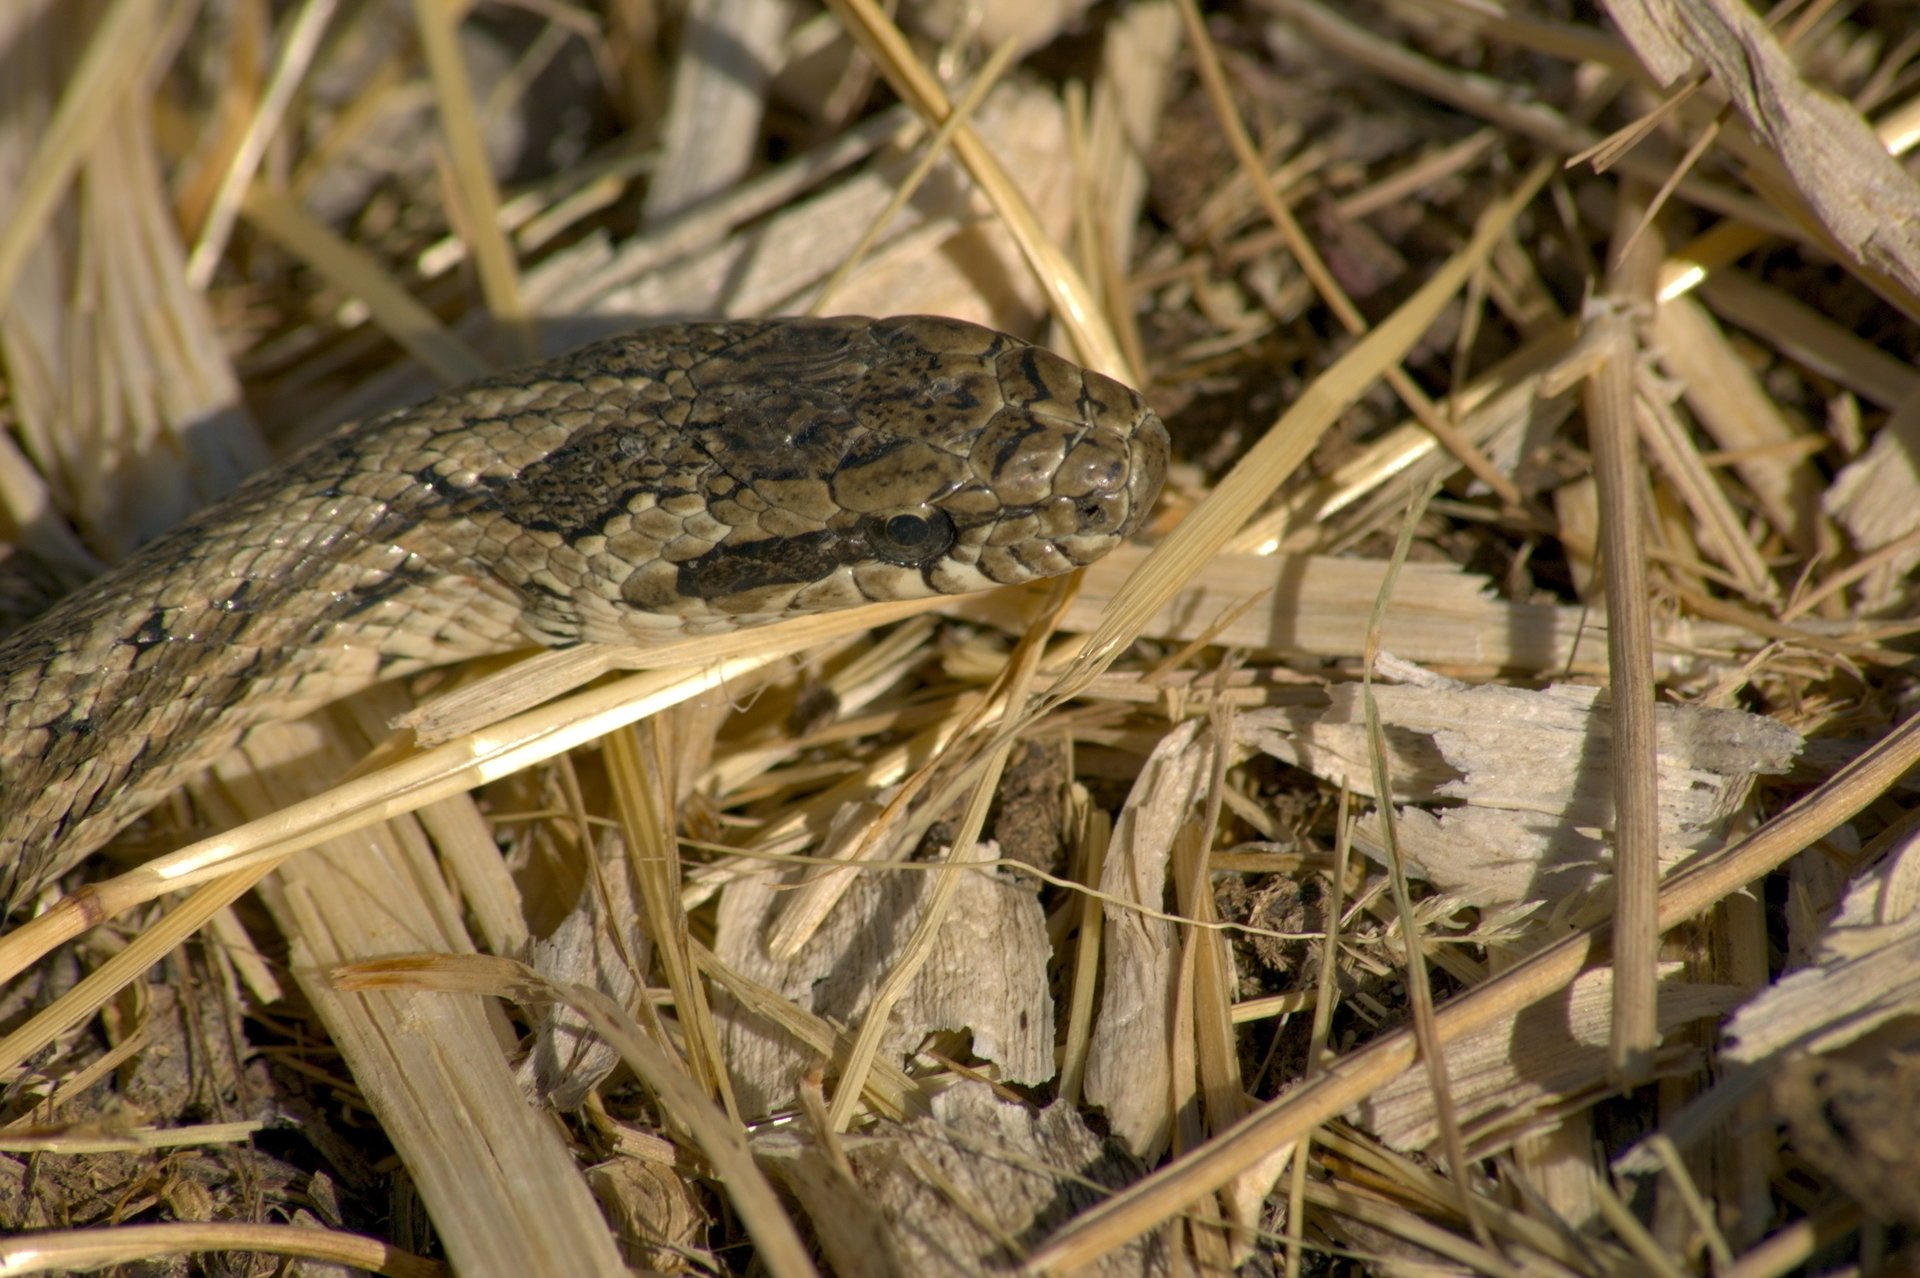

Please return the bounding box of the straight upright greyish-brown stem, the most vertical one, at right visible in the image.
[1586,204,1661,1084]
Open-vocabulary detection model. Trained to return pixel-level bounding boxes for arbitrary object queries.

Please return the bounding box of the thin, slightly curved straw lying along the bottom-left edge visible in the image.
[0,1220,451,1278]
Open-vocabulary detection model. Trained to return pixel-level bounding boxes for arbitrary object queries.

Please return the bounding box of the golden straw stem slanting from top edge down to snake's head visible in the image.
[828,0,1140,384]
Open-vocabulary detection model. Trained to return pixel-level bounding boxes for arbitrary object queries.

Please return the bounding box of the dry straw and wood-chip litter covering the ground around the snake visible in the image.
[0,0,1920,1274]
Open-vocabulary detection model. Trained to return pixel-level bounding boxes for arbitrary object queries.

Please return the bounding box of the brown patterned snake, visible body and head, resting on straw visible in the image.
[0,315,1169,913]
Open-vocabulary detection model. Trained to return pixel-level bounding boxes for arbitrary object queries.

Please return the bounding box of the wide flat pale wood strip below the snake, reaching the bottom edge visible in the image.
[228,702,626,1278]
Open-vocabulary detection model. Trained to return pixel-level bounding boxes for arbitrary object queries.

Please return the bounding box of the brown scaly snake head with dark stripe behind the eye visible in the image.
[490,315,1167,641]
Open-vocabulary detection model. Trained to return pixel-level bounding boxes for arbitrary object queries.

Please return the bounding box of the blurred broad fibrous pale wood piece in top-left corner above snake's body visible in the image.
[0,2,265,568]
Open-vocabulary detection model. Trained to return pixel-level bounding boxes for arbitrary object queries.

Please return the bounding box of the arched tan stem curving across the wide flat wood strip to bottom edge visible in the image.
[330,954,818,1278]
